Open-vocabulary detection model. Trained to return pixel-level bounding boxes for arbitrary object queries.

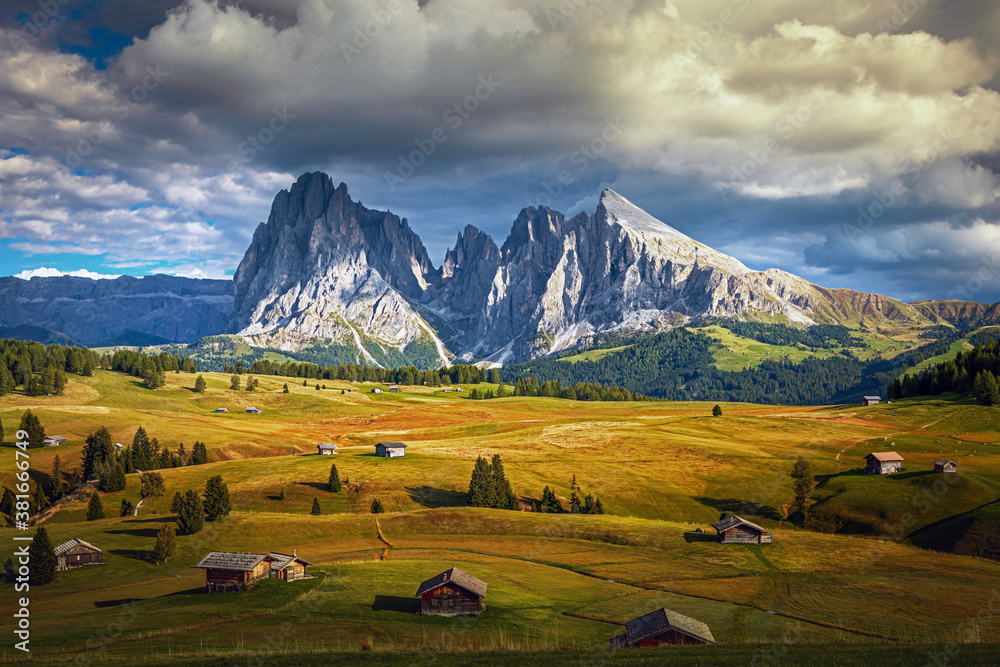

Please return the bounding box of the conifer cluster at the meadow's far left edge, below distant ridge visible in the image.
[0,340,100,396]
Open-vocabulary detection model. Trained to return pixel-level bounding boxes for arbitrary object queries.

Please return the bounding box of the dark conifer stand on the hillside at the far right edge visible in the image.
[886,338,1000,405]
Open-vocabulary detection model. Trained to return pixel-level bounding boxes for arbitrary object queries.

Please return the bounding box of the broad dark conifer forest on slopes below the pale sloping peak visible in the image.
[501,328,960,405]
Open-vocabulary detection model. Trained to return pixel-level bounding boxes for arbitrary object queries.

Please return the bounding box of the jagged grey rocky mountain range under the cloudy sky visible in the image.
[0,173,1000,367]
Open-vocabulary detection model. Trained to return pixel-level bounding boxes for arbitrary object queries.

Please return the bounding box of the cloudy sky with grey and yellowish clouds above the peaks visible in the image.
[0,0,1000,302]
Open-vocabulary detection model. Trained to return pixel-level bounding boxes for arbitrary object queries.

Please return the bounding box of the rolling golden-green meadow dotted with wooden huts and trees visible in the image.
[0,371,1000,661]
